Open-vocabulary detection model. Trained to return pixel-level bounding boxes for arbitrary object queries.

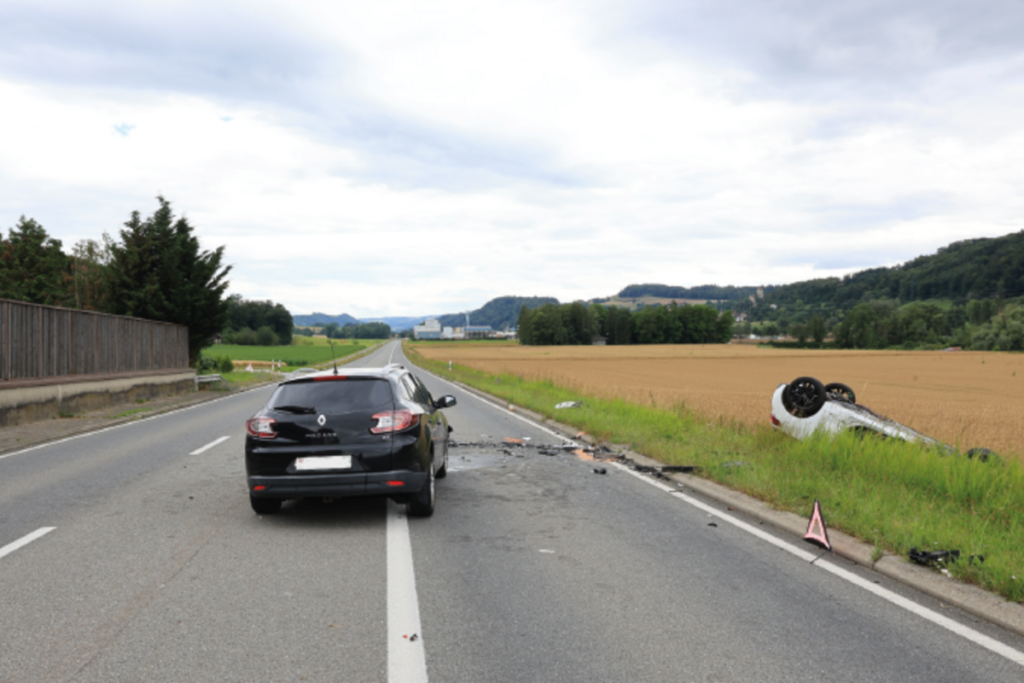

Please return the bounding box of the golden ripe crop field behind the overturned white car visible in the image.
[417,342,1024,458]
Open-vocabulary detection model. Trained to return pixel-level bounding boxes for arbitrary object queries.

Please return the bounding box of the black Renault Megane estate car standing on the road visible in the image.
[246,365,455,517]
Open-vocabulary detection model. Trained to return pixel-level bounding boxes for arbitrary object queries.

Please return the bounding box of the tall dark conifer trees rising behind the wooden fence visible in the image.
[0,197,231,362]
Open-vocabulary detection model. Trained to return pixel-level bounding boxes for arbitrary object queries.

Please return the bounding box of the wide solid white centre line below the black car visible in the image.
[387,501,427,683]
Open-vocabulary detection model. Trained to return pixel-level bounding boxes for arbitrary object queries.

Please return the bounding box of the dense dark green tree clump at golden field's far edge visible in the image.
[518,301,734,346]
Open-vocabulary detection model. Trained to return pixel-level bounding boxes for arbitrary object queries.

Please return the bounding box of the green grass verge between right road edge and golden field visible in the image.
[406,345,1024,602]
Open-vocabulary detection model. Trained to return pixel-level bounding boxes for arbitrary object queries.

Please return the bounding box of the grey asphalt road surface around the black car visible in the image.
[0,344,1024,683]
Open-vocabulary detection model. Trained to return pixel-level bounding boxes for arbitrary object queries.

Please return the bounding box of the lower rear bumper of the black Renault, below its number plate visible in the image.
[249,470,427,498]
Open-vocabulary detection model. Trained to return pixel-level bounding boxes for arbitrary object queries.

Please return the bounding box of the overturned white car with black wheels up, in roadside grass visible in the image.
[771,377,992,461]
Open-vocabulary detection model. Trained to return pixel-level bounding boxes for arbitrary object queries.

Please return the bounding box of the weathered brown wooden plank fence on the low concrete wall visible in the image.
[0,299,188,389]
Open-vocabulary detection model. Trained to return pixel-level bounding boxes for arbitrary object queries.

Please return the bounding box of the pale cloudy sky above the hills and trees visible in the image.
[0,0,1024,316]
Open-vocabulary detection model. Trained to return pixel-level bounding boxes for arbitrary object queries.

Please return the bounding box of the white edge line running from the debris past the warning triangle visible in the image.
[610,463,1024,666]
